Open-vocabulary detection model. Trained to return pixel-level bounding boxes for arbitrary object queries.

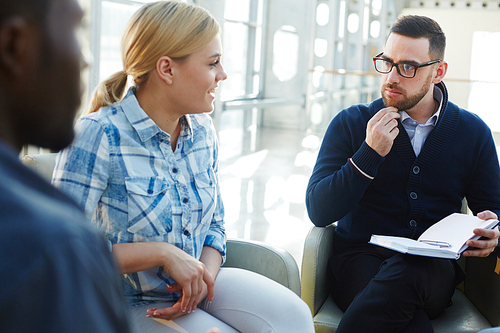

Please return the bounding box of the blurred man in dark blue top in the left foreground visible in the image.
[0,0,129,333]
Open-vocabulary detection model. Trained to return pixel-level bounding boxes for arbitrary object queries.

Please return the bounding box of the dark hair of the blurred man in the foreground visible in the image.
[0,0,53,25]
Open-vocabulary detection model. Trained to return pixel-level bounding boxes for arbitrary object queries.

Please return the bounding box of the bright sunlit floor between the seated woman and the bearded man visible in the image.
[219,110,321,269]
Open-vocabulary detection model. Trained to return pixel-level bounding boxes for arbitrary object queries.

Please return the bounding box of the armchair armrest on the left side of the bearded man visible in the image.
[301,224,335,316]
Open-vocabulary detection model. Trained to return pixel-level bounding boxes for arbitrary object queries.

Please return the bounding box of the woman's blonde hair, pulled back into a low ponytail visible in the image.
[86,1,220,114]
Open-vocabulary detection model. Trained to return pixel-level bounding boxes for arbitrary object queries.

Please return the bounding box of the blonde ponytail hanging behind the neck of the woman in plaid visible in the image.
[85,71,127,114]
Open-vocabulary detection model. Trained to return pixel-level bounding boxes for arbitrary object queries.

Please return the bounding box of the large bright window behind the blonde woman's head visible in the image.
[85,0,266,110]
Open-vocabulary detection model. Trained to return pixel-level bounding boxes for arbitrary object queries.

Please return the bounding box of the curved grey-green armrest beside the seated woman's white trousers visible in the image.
[224,239,300,297]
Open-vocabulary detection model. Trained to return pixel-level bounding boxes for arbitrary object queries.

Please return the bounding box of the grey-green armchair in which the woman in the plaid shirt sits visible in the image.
[22,154,300,296]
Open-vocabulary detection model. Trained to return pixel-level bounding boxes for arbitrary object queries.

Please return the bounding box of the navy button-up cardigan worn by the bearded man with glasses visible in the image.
[306,82,500,242]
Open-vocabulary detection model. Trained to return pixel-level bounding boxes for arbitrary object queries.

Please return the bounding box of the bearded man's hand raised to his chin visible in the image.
[366,107,400,157]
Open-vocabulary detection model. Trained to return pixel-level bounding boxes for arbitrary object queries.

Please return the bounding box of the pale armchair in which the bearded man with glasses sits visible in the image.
[301,224,500,333]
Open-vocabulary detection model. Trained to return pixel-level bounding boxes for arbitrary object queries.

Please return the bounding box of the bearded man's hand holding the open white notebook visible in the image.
[462,210,500,257]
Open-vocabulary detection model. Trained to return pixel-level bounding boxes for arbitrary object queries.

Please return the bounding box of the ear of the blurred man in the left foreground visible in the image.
[0,16,40,76]
